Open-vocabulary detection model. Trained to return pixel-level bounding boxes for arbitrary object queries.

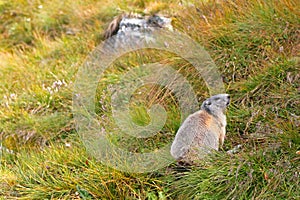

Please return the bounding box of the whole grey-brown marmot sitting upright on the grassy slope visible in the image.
[171,94,230,164]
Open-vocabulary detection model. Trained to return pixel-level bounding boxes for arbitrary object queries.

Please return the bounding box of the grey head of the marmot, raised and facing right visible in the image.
[201,94,230,117]
